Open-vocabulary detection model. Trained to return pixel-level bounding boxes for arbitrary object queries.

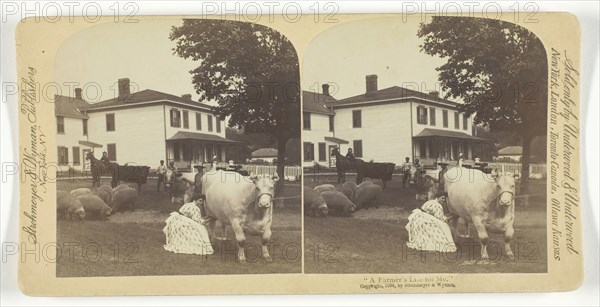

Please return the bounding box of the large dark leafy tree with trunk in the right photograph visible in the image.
[418,17,548,202]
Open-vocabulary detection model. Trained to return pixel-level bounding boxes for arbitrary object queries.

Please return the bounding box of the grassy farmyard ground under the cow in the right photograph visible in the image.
[304,175,547,273]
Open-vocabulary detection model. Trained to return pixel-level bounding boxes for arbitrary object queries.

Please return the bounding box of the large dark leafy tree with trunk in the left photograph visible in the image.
[170,19,300,206]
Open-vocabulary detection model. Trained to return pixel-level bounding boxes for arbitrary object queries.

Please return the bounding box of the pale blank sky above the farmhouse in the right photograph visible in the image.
[302,16,446,99]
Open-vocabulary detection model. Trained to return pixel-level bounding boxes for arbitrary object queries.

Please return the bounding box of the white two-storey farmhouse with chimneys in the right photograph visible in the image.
[303,75,489,166]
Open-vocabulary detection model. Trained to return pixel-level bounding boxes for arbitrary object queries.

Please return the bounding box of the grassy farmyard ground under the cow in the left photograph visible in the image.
[56,179,302,277]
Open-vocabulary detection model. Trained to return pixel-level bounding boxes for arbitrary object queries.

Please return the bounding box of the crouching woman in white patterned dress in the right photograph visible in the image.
[406,192,456,253]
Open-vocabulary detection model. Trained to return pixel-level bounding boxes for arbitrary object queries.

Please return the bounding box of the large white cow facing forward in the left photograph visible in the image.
[202,170,279,262]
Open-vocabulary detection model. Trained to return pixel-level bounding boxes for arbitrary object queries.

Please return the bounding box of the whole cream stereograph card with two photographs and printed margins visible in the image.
[17,13,585,296]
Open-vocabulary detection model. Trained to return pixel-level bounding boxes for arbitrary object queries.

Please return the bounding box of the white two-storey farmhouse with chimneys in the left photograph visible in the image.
[55,79,239,169]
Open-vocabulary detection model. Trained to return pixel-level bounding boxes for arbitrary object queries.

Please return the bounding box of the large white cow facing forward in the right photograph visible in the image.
[444,167,518,260]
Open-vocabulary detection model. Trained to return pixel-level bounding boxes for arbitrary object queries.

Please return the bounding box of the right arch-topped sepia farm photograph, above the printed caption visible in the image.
[302,16,548,274]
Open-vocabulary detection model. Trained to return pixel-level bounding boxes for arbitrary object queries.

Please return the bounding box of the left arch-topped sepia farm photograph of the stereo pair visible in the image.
[48,18,302,277]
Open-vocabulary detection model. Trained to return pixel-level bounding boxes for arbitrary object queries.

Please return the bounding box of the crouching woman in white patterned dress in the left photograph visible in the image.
[163,195,214,255]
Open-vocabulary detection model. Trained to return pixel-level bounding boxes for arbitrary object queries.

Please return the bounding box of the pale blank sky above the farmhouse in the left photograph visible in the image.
[54,19,204,102]
